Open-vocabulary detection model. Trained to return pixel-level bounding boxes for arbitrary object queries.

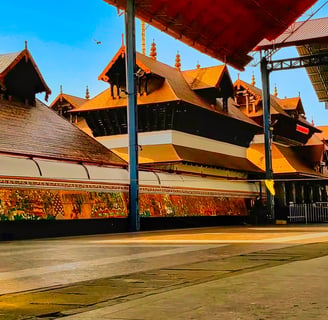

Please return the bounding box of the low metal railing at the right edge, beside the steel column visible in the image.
[288,202,328,223]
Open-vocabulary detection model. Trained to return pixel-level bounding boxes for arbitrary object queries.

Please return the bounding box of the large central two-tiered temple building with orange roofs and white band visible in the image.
[70,46,262,179]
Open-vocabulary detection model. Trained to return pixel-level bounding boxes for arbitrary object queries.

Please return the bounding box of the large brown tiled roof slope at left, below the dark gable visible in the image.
[0,100,126,165]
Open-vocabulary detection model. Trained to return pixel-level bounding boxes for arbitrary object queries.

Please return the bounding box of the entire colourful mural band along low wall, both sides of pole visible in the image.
[0,188,247,220]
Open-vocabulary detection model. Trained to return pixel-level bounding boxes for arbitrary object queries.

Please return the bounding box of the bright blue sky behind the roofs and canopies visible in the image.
[0,0,328,125]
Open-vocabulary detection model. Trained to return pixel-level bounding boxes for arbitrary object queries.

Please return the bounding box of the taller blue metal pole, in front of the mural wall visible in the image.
[125,0,140,232]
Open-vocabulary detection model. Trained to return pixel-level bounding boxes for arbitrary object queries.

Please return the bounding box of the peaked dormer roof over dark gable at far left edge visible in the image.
[0,49,51,100]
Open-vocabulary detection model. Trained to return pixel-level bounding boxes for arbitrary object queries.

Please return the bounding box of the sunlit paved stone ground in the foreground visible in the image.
[0,225,328,320]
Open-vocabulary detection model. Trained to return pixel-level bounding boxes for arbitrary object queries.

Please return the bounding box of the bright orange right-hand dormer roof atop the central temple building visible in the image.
[182,64,227,90]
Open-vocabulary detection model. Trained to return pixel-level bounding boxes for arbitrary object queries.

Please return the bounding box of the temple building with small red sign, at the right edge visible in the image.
[234,78,328,208]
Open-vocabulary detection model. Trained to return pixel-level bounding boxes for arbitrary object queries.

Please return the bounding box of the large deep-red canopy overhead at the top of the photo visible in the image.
[104,0,316,70]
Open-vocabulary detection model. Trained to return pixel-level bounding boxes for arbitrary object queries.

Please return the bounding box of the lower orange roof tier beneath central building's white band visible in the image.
[112,144,261,172]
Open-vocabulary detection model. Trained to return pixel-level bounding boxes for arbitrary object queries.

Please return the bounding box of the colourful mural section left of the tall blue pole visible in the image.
[0,189,128,220]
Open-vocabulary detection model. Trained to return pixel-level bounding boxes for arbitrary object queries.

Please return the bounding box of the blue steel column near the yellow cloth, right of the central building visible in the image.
[261,58,274,222]
